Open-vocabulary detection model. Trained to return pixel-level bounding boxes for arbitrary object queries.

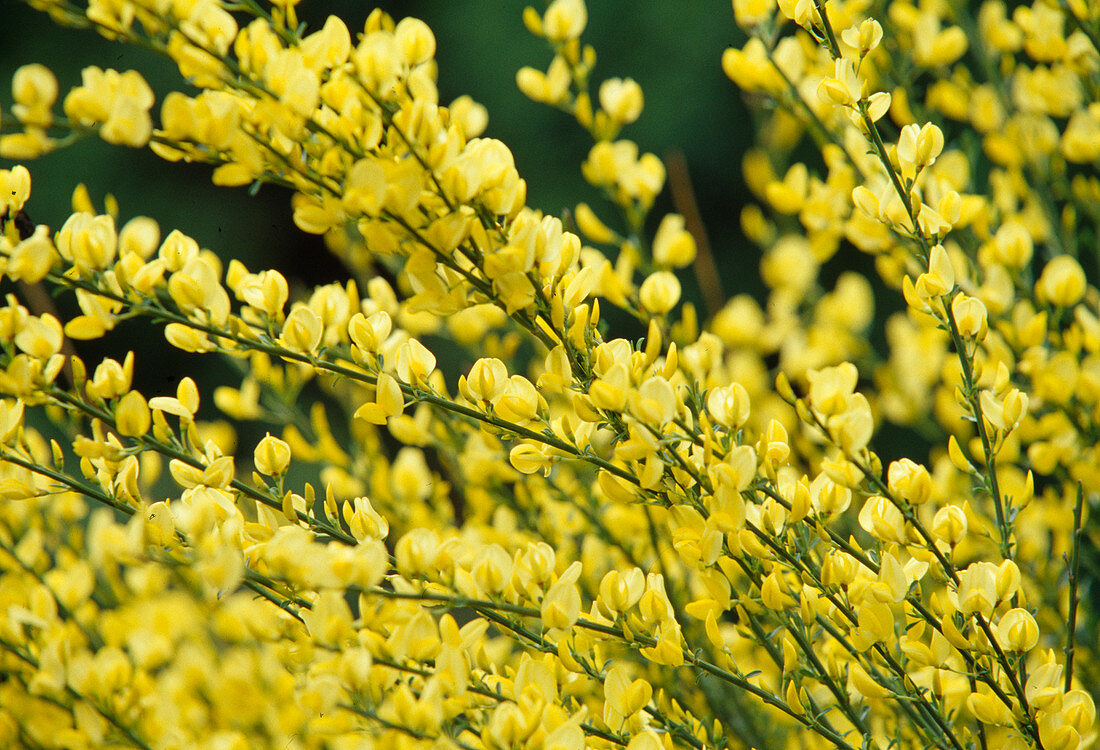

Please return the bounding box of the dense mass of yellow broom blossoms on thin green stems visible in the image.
[0,0,1100,750]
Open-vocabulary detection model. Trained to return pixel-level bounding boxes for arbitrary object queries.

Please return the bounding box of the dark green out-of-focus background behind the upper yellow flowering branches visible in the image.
[0,0,757,290]
